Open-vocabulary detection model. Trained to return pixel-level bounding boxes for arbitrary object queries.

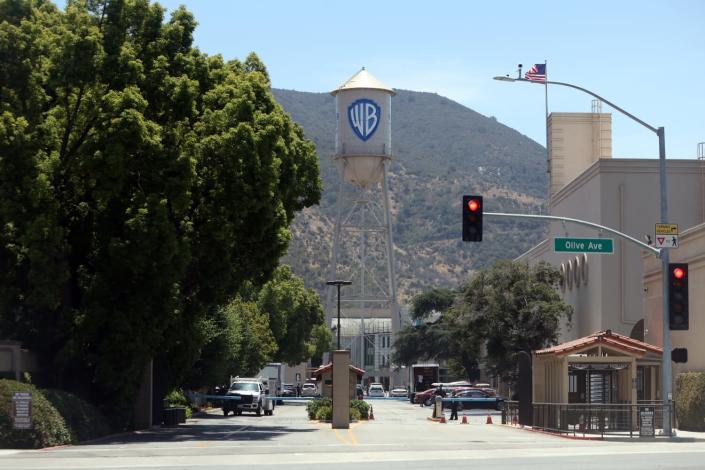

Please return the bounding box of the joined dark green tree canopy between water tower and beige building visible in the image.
[395,261,572,382]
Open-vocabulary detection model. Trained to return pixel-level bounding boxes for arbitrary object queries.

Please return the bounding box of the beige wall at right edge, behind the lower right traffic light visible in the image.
[642,224,705,377]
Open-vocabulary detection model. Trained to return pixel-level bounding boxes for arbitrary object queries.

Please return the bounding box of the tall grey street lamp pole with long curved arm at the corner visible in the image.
[494,76,672,436]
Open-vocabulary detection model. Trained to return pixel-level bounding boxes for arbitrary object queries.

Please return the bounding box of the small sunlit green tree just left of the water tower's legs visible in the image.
[257,265,332,364]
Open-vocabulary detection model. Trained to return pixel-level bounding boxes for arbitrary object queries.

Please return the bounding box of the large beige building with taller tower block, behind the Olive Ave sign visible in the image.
[518,113,705,344]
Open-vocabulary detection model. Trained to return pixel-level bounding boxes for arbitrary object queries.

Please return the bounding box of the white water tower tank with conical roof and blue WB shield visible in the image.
[331,67,394,187]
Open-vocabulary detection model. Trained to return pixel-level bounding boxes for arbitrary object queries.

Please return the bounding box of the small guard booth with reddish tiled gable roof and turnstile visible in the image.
[532,330,662,432]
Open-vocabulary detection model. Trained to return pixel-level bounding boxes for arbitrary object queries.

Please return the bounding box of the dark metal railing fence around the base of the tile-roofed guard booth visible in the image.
[532,401,675,437]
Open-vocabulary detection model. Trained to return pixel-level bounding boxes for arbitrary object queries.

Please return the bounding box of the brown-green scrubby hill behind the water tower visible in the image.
[273,89,548,303]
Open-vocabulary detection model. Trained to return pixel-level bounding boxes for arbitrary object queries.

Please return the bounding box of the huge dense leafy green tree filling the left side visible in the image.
[0,0,321,424]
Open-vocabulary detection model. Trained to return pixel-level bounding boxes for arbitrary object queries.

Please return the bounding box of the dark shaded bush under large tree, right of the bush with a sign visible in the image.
[42,389,111,442]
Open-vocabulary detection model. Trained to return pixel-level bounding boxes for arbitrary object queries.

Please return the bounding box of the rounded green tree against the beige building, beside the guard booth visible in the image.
[461,261,572,382]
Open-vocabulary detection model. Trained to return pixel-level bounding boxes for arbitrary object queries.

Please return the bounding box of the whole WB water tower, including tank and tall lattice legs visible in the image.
[326,68,400,385]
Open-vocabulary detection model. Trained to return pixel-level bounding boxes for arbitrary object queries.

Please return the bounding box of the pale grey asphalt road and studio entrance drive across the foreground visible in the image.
[0,401,705,470]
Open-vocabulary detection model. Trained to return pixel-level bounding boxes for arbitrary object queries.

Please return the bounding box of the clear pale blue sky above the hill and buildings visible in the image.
[67,0,705,158]
